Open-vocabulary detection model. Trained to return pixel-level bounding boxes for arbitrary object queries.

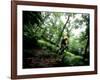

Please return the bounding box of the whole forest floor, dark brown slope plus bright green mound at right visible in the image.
[23,42,84,68]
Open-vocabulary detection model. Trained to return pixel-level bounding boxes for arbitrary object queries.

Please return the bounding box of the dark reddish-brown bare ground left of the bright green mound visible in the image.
[23,48,61,68]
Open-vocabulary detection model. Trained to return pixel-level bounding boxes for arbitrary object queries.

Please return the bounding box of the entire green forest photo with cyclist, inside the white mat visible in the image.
[23,11,90,68]
